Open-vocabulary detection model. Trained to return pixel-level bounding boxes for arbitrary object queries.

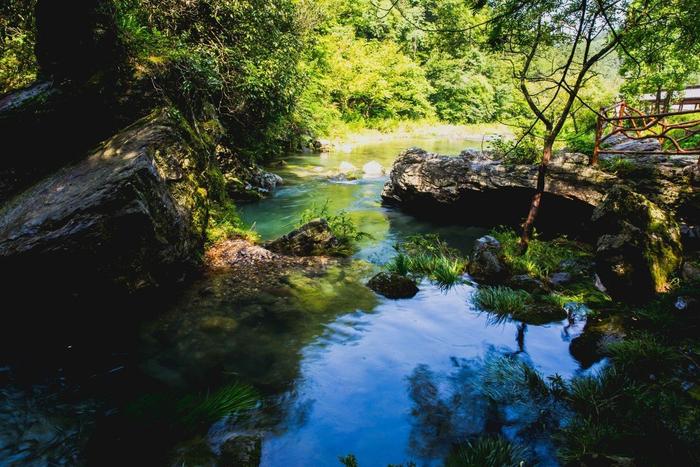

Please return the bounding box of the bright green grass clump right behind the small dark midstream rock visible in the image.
[385,234,467,287]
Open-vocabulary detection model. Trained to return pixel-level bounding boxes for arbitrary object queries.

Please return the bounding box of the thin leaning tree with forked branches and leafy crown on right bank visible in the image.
[380,0,698,248]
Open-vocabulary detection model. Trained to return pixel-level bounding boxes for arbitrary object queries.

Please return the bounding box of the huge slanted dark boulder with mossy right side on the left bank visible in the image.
[0,112,208,299]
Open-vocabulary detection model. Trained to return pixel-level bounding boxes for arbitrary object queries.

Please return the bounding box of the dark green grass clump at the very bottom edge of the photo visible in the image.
[445,436,526,467]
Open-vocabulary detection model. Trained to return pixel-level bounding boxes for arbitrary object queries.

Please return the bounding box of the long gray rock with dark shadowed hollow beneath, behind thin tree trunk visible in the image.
[382,148,615,234]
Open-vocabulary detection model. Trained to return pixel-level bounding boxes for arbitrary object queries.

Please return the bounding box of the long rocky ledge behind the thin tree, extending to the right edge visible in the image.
[382,148,700,233]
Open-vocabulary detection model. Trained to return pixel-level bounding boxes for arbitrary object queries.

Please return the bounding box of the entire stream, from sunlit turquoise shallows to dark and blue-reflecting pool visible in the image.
[0,140,584,467]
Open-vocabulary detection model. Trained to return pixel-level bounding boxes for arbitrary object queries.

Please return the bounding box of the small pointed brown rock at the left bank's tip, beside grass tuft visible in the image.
[265,219,341,256]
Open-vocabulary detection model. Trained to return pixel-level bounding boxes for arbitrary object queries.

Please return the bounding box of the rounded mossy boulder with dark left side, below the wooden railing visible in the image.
[591,186,682,301]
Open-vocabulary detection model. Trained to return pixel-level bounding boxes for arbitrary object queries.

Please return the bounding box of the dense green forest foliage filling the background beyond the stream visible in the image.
[5,0,698,157]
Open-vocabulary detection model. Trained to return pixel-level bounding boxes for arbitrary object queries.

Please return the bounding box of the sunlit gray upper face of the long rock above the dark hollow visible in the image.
[382,148,615,206]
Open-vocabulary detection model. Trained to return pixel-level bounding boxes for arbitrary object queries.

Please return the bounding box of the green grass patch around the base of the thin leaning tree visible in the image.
[491,229,591,280]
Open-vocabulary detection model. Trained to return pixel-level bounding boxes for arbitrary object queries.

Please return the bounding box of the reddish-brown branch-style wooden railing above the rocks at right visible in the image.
[591,102,700,165]
